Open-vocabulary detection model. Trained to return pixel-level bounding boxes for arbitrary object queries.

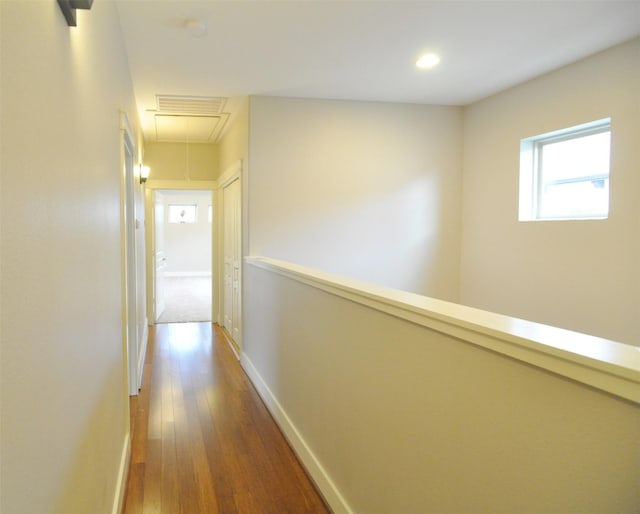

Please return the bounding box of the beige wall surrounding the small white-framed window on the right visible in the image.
[460,39,640,344]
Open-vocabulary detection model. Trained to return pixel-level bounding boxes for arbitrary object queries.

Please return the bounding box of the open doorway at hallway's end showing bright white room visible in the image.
[154,190,214,323]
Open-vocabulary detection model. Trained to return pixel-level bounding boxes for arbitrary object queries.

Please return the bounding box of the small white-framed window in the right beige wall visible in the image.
[519,118,611,221]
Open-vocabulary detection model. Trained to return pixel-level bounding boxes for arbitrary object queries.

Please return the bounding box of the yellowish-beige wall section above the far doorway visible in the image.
[144,143,218,181]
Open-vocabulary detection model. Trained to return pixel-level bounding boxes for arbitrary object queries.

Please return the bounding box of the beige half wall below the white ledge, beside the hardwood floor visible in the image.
[243,265,640,514]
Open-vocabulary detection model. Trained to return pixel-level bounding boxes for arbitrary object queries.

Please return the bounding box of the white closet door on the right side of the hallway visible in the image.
[222,179,242,343]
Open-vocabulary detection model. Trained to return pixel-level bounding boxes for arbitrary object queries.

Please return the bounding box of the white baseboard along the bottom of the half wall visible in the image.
[240,352,353,514]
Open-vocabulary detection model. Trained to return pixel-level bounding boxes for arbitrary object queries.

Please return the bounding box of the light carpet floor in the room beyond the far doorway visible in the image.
[157,277,211,323]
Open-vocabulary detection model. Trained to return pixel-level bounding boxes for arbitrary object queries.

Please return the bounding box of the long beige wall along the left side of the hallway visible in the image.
[0,1,136,514]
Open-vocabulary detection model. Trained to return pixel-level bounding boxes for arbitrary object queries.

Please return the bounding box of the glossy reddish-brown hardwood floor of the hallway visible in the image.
[123,323,330,514]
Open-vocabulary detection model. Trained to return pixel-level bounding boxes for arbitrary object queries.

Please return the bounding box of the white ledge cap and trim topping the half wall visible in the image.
[245,257,640,403]
